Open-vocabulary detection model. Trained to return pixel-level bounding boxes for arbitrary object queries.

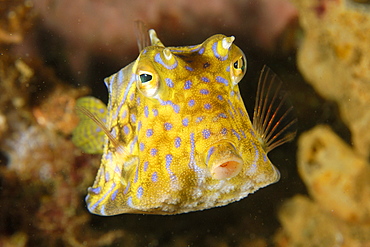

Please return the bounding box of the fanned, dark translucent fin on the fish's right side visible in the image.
[253,66,297,152]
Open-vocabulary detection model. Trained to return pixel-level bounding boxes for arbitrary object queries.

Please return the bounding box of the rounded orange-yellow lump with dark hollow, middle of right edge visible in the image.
[298,126,370,224]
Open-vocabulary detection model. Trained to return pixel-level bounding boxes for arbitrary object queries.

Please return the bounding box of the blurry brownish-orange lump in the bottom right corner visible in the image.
[276,195,370,247]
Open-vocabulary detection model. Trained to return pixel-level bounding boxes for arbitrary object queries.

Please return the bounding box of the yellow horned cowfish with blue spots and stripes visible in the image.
[73,30,295,215]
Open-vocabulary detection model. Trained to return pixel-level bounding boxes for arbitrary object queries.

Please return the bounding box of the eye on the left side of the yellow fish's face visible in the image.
[136,70,159,97]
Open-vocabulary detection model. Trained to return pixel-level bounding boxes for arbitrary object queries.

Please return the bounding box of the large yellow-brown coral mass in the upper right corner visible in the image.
[295,0,370,156]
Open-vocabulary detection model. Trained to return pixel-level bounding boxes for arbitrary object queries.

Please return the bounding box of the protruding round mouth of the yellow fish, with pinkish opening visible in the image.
[206,142,244,180]
